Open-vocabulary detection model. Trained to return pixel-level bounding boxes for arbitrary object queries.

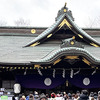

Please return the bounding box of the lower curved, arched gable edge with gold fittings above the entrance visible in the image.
[31,47,100,65]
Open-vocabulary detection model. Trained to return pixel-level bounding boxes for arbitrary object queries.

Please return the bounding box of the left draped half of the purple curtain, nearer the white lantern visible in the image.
[16,74,66,89]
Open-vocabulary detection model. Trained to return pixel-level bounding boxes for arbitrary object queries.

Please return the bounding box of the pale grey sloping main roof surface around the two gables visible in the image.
[0,36,100,64]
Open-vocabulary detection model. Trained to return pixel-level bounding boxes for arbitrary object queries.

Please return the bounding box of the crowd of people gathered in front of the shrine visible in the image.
[14,90,100,100]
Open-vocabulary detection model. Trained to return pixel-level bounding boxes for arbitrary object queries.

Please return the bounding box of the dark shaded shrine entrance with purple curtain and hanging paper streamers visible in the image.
[0,57,100,93]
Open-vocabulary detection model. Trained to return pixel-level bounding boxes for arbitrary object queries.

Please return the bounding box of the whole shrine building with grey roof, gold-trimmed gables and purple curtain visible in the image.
[0,4,100,91]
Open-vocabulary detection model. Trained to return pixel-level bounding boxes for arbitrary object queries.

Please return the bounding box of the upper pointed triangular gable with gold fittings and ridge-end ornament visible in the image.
[25,6,100,47]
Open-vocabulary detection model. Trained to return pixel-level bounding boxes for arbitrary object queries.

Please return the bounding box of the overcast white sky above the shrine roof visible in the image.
[0,0,100,28]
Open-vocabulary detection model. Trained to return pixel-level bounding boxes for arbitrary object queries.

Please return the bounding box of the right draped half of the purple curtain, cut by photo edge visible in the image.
[68,74,100,88]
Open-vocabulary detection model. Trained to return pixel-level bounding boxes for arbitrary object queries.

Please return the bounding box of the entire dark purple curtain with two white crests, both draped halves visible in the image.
[16,74,100,89]
